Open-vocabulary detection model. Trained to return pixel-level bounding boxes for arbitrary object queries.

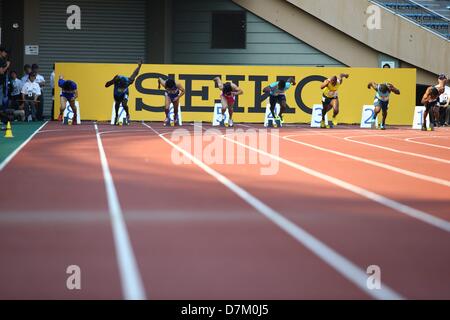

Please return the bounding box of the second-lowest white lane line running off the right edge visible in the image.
[279,135,450,187]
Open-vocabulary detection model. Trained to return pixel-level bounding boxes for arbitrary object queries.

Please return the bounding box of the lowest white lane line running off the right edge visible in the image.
[222,131,450,232]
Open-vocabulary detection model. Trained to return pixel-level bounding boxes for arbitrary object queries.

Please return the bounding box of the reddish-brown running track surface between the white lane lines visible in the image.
[0,123,450,299]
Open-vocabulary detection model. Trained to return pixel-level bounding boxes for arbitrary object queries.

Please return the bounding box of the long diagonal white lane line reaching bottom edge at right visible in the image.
[143,123,403,299]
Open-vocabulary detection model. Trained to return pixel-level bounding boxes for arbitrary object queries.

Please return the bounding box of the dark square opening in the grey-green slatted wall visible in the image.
[211,11,247,49]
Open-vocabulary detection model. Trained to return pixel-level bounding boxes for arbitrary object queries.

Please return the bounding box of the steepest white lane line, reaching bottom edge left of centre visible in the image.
[94,124,146,300]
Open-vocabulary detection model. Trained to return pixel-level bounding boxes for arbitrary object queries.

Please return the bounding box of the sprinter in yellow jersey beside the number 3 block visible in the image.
[320,73,349,128]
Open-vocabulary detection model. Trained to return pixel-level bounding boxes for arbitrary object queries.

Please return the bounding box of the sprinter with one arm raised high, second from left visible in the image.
[105,60,142,125]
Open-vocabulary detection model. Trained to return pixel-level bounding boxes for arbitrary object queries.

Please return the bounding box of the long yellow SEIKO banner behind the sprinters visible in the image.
[54,63,416,125]
